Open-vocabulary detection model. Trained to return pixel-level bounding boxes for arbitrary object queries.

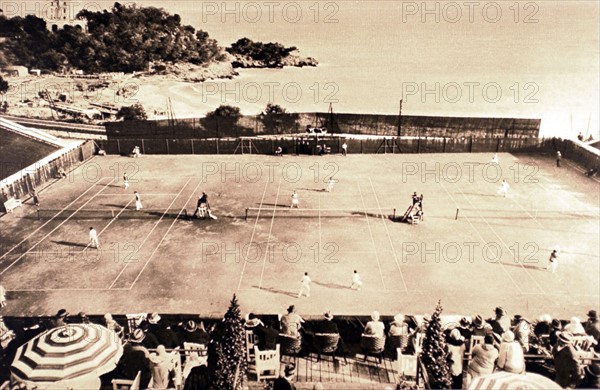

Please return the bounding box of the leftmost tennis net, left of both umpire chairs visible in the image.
[31,208,188,220]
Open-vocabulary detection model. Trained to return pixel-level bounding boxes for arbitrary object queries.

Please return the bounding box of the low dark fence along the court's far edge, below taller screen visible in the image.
[97,136,546,155]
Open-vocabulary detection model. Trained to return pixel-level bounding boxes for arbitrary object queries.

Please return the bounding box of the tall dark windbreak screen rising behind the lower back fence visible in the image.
[105,113,541,139]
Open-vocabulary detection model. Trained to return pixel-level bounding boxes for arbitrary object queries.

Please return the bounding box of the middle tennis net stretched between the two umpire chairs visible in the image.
[245,207,396,220]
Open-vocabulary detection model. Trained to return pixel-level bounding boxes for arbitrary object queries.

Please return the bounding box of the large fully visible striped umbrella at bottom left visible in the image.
[11,324,123,384]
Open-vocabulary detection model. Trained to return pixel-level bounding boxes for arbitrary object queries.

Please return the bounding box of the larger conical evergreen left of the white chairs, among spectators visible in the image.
[212,294,246,390]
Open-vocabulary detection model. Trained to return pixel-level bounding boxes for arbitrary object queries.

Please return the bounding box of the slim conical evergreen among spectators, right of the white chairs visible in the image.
[421,301,452,389]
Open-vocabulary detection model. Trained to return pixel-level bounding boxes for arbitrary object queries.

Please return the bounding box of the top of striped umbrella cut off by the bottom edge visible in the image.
[469,371,562,390]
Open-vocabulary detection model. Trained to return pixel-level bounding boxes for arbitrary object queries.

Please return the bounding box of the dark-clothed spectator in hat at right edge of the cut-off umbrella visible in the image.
[552,332,582,388]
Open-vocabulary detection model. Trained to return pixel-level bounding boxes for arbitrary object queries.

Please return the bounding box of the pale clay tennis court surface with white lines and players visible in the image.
[0,154,600,317]
